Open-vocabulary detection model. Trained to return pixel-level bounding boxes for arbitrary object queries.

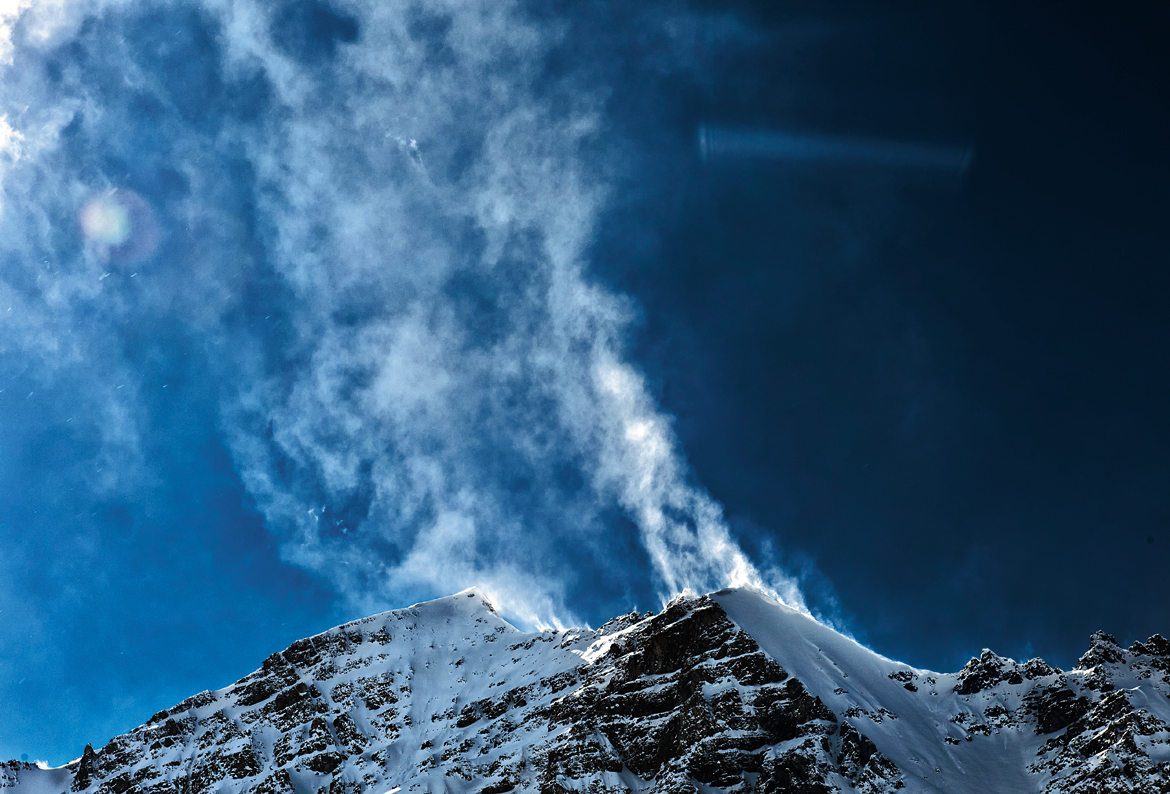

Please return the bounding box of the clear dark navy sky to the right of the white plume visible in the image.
[600,4,1170,669]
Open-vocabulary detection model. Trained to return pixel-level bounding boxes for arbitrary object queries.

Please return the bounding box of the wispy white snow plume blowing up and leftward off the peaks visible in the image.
[0,0,799,623]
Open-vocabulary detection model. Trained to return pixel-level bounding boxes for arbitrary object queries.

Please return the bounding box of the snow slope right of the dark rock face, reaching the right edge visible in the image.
[713,589,1170,794]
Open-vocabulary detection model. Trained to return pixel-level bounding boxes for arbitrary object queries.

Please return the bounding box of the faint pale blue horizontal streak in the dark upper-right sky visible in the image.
[698,124,973,175]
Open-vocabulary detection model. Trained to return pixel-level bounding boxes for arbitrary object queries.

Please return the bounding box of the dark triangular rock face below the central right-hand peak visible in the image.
[519,598,896,792]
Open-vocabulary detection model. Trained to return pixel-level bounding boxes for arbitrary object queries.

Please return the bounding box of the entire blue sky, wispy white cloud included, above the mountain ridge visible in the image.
[0,1,1170,764]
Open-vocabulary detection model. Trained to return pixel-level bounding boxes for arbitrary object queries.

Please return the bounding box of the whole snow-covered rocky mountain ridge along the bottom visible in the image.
[0,589,1170,794]
